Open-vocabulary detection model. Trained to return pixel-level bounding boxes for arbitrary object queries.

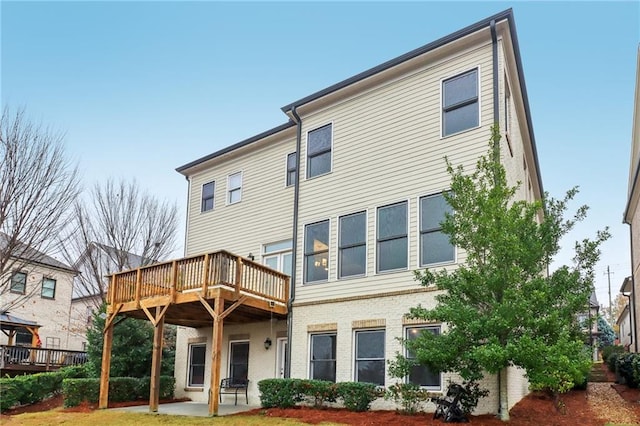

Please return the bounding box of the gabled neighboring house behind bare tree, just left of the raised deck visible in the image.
[69,242,150,350]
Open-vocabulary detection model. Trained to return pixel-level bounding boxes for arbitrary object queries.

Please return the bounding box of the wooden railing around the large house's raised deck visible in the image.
[107,251,289,304]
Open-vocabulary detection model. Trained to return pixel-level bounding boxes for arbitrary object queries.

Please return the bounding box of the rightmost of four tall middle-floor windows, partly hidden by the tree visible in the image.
[420,194,455,266]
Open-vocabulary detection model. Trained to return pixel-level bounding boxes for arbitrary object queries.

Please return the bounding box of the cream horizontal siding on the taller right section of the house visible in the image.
[296,44,493,302]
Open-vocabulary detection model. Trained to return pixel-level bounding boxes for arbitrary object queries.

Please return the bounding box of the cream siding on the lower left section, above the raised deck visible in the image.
[185,133,296,259]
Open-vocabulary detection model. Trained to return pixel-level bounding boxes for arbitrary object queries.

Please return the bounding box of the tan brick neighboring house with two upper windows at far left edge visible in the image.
[0,236,82,350]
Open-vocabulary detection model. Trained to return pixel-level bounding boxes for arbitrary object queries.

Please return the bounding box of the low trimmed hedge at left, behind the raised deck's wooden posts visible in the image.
[62,376,176,407]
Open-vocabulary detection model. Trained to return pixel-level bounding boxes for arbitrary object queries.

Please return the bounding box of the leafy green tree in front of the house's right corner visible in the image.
[391,128,609,420]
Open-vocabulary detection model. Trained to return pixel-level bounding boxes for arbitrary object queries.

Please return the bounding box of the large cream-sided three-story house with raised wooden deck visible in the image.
[101,10,543,414]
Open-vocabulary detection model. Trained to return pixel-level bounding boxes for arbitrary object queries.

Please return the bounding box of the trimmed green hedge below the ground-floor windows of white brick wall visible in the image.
[258,379,381,411]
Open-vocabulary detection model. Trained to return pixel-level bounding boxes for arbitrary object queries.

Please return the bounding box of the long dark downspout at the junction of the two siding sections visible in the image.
[284,106,302,378]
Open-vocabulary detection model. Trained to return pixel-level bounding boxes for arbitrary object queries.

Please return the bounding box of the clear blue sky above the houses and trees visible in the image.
[0,0,640,312]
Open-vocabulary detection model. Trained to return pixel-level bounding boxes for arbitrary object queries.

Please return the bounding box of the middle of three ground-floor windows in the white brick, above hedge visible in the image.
[355,330,385,386]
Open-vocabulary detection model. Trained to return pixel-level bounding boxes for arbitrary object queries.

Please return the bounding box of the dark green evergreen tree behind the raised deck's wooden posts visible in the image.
[87,305,175,377]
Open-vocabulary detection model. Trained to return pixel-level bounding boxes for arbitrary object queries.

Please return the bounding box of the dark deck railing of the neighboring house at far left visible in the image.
[0,345,87,370]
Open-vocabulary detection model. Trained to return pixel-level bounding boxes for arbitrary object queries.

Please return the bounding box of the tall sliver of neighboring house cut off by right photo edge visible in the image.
[624,46,640,352]
